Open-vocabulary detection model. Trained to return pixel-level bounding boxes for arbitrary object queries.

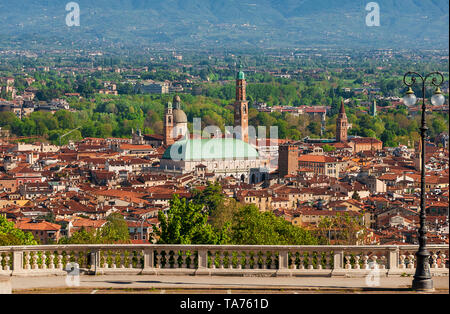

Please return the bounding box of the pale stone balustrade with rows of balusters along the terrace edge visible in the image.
[0,244,449,277]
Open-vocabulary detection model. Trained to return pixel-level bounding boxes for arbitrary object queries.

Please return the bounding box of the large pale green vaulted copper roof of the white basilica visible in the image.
[162,138,259,161]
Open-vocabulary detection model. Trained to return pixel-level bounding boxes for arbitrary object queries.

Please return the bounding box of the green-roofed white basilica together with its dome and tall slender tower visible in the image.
[160,71,269,183]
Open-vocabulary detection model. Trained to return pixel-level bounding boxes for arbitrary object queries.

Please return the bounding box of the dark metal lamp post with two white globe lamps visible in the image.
[403,72,445,291]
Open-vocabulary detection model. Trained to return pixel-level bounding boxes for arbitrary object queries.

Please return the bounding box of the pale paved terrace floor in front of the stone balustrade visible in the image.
[11,275,449,294]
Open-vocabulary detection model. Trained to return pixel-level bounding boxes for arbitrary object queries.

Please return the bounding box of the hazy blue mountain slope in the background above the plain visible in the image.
[0,0,449,49]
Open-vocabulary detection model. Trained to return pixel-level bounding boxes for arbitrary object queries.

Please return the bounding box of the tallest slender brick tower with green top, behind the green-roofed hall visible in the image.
[234,70,248,143]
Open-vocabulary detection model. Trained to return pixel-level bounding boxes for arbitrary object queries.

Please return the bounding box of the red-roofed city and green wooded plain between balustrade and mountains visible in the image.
[0,50,449,248]
